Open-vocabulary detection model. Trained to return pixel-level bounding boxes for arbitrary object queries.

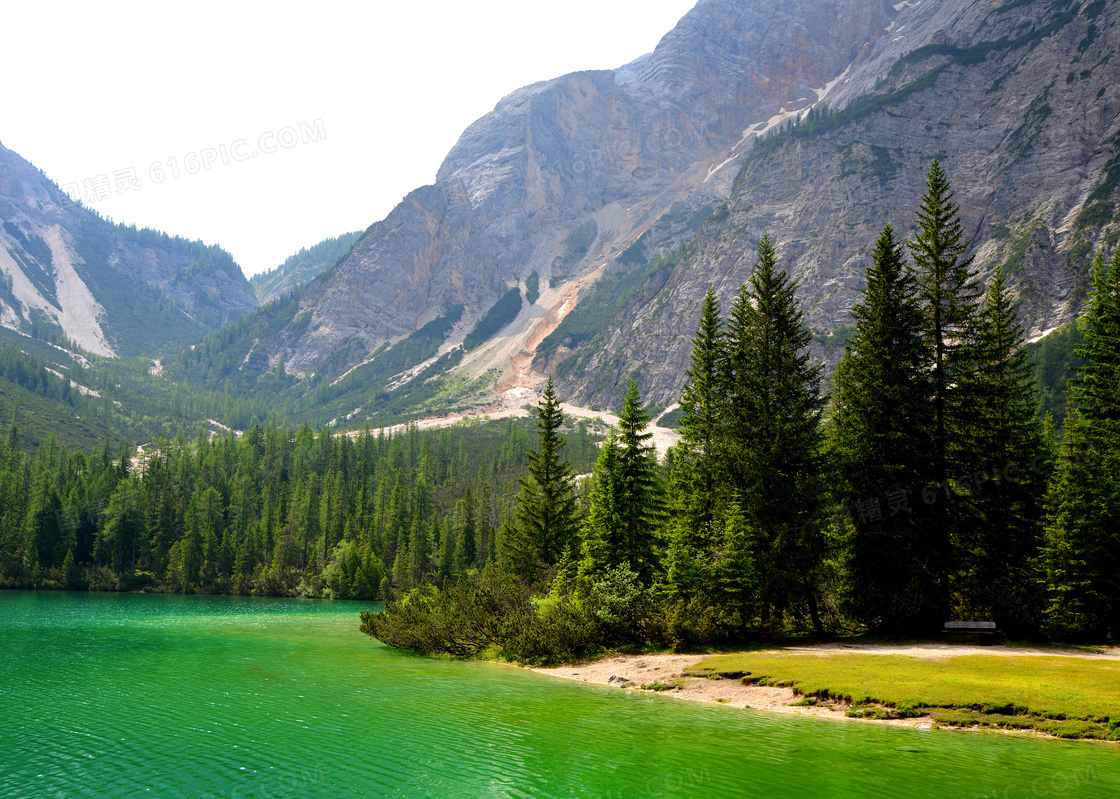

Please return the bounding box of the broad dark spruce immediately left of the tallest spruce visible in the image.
[832,225,937,630]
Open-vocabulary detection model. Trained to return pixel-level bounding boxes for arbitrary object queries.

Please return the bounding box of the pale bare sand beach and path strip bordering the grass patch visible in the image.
[532,643,1120,734]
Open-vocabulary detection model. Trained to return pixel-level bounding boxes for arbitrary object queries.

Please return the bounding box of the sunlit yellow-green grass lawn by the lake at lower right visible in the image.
[690,652,1120,741]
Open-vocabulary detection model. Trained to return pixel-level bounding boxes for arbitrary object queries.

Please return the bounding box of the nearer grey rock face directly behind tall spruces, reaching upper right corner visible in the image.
[560,0,1120,407]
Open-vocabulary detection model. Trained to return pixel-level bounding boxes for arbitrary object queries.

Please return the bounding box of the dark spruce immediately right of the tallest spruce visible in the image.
[954,267,1052,634]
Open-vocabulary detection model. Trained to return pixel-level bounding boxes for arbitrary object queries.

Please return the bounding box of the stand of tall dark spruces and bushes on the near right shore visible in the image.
[363,161,1120,661]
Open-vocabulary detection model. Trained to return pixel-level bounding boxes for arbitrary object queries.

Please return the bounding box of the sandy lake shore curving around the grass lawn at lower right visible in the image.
[532,643,1120,737]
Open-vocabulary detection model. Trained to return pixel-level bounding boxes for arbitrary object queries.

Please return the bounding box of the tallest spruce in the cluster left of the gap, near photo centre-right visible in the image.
[726,234,824,630]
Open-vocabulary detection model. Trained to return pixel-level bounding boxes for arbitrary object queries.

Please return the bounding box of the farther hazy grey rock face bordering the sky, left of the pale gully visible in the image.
[263,0,894,371]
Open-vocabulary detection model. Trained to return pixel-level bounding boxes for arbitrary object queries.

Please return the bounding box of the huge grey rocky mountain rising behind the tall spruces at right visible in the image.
[211,0,1120,418]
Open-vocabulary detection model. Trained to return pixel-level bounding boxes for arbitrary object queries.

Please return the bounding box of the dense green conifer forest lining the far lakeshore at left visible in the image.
[0,412,597,598]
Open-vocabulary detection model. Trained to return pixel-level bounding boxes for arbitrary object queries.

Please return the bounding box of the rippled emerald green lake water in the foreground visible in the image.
[0,592,1120,799]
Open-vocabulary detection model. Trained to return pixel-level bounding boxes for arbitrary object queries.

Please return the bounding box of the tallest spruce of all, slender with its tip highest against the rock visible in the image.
[909,159,980,625]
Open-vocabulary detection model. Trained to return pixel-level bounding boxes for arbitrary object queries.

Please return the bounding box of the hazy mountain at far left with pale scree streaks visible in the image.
[0,145,258,355]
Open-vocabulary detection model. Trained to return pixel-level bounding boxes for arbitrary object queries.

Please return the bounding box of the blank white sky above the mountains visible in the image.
[0,0,694,275]
